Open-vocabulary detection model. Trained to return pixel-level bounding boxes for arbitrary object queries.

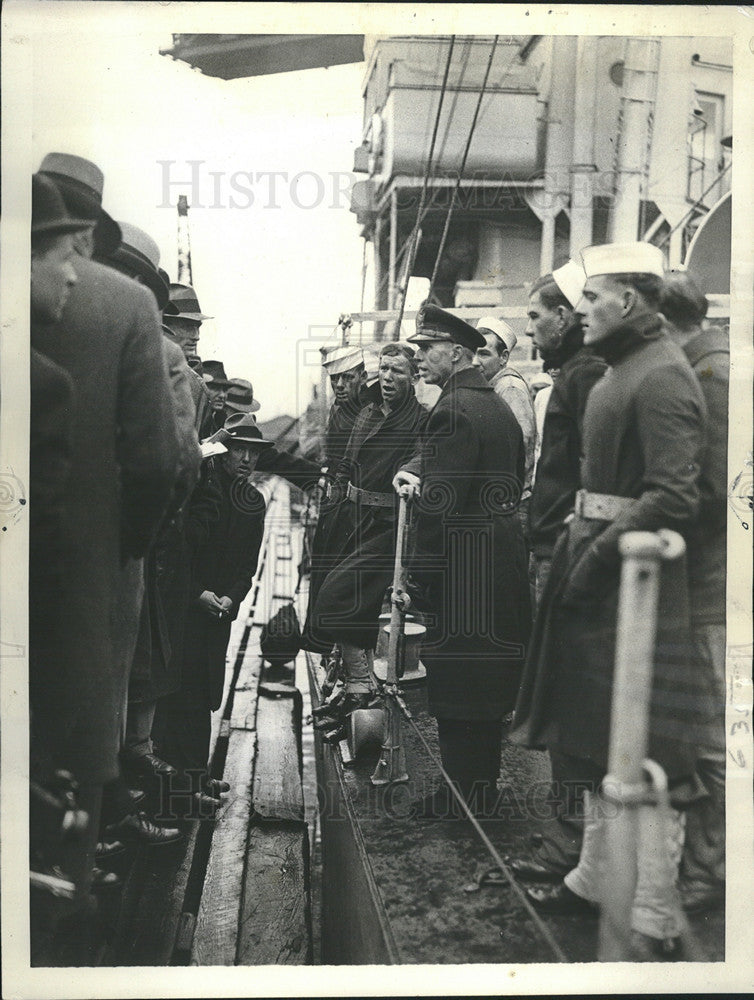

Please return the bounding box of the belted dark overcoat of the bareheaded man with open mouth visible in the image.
[314,391,427,649]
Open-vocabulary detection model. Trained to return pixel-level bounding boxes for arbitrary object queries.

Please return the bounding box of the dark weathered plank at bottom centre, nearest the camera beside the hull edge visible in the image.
[237,823,311,965]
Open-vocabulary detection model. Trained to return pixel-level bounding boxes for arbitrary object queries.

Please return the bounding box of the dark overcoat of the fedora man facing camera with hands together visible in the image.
[183,463,266,711]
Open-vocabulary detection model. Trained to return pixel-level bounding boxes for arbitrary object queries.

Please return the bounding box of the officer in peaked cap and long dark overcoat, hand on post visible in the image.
[394,305,531,818]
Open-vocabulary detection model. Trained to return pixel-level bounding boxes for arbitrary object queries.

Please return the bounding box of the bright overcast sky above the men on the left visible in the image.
[28,27,372,418]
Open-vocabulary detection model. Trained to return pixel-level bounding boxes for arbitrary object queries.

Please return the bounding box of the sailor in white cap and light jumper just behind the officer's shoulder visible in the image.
[474,316,537,538]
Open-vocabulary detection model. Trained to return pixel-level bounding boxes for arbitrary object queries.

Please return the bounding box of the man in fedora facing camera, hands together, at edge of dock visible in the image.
[155,414,272,809]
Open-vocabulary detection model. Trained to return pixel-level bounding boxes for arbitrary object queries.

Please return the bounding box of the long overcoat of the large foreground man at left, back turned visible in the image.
[32,259,177,784]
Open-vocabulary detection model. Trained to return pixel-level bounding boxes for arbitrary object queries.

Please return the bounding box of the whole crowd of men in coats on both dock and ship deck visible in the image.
[30,153,728,955]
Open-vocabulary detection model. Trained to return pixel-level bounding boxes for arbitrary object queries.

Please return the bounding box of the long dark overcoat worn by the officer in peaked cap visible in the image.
[400,368,531,721]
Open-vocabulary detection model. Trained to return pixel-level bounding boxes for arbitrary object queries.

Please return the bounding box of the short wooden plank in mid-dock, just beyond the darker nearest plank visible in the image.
[253,684,304,821]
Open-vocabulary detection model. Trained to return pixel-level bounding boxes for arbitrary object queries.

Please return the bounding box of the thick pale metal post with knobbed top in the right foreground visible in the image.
[599,531,685,962]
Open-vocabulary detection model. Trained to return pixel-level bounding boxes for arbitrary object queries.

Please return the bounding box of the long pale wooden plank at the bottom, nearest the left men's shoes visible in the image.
[191,729,257,965]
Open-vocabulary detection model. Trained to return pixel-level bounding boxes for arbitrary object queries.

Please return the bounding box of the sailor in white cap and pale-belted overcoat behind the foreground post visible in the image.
[511,243,710,956]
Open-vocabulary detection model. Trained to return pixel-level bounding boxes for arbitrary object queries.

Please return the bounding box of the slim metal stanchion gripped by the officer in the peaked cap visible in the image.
[371,495,408,785]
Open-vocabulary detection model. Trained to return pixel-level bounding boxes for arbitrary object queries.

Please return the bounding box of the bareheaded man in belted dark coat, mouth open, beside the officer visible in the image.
[314,343,427,728]
